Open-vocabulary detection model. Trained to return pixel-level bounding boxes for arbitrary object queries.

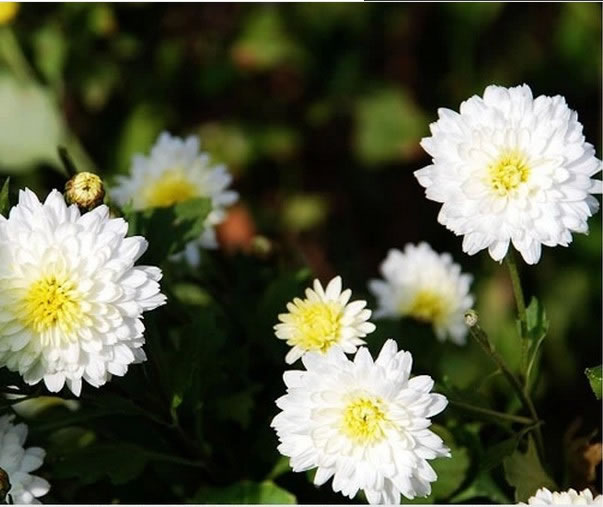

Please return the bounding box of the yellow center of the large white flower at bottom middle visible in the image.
[341,396,387,444]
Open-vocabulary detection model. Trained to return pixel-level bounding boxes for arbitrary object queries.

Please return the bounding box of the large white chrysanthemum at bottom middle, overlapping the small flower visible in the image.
[272,340,450,504]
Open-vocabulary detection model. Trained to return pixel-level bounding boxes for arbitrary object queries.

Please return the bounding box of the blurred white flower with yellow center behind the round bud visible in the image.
[109,132,239,266]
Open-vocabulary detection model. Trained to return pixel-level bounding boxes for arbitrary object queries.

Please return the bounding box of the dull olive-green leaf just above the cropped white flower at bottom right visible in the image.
[503,437,557,502]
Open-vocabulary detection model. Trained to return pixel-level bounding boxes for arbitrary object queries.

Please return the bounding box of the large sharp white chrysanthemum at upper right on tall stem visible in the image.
[415,85,601,264]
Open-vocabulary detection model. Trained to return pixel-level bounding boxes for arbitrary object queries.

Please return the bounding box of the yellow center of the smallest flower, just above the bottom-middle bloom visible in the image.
[291,301,343,353]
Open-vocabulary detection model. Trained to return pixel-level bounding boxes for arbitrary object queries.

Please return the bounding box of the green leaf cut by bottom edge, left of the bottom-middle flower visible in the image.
[191,481,296,504]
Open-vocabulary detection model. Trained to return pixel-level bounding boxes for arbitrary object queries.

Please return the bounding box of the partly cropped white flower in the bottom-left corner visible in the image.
[0,415,50,504]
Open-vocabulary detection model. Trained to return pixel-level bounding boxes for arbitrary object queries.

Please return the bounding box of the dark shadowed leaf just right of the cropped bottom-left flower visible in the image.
[53,442,149,484]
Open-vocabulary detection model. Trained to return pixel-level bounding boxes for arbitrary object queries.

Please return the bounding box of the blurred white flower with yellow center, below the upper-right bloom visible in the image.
[369,243,473,345]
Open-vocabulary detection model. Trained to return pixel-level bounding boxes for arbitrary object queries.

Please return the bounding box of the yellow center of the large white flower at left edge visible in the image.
[22,275,83,334]
